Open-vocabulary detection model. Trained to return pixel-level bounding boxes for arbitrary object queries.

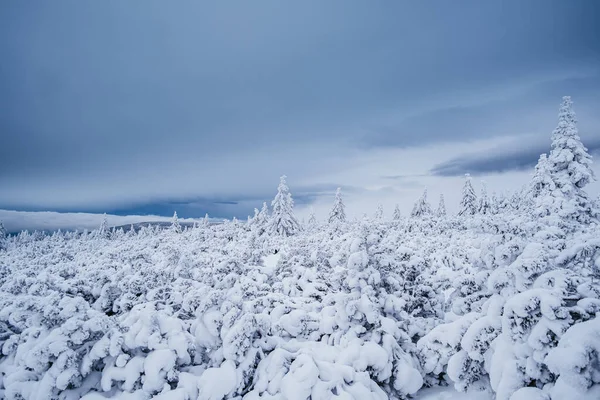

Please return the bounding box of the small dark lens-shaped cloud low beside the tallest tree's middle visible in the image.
[430,137,600,176]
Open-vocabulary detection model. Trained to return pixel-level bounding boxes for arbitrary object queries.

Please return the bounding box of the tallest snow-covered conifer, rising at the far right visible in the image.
[548,96,595,220]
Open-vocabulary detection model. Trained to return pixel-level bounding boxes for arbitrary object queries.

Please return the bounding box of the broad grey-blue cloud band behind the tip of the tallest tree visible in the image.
[362,72,600,148]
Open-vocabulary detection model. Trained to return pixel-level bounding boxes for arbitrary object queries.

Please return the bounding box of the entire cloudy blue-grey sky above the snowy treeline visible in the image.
[0,0,600,227]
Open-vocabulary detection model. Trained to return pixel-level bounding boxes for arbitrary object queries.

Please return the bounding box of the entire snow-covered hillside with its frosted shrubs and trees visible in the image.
[0,98,600,400]
